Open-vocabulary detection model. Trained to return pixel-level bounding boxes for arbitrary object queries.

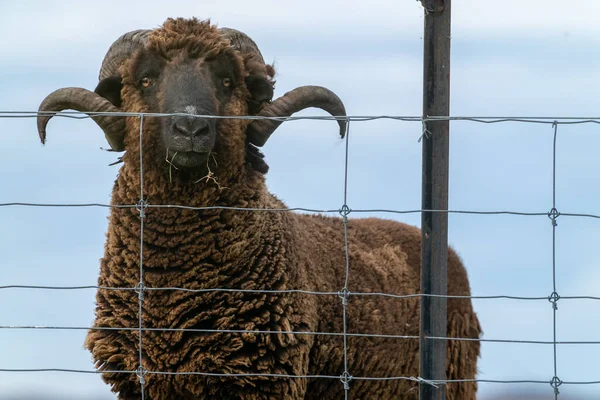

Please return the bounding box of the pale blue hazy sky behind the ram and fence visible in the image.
[0,0,600,399]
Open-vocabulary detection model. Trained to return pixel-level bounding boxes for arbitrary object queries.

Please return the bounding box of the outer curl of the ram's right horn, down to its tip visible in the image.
[247,86,346,147]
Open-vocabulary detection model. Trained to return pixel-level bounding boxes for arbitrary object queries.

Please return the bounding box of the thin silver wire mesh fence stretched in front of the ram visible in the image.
[0,111,600,399]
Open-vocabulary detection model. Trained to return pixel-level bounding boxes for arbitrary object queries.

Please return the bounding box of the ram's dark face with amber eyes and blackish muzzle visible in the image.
[96,50,243,168]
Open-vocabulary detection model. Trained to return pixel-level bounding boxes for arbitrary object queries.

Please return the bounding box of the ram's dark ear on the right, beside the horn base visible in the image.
[245,59,275,115]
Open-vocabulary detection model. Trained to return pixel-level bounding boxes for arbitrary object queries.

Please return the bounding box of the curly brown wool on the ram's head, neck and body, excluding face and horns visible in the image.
[40,19,481,400]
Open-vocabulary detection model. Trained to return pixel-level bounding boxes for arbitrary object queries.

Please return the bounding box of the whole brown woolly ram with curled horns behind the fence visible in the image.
[38,19,481,400]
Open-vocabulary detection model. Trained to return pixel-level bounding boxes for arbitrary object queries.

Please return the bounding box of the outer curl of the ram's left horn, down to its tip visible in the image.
[37,87,125,151]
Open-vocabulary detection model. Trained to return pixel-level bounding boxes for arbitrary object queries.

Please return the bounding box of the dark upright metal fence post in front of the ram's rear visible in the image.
[419,0,450,400]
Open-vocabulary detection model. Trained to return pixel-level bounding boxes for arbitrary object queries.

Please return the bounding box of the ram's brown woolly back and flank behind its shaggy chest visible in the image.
[290,215,480,400]
